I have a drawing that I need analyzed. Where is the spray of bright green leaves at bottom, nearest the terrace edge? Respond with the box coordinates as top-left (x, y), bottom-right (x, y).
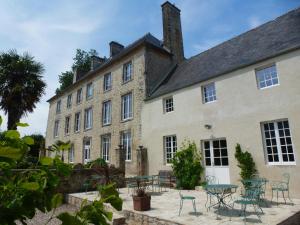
top-left (57, 184), bottom-right (123, 225)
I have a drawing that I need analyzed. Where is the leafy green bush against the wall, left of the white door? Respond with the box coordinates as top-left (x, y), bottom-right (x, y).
top-left (172, 141), bottom-right (203, 189)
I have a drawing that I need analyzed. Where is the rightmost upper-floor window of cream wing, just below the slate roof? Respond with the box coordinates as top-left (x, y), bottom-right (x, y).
top-left (255, 65), bottom-right (279, 89)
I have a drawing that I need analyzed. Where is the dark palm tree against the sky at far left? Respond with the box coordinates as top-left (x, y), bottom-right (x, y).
top-left (0, 50), bottom-right (46, 130)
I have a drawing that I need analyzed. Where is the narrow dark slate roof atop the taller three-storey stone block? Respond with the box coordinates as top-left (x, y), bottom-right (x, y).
top-left (47, 33), bottom-right (171, 102)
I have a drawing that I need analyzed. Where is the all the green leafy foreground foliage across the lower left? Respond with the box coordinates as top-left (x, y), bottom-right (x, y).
top-left (0, 117), bottom-right (122, 225)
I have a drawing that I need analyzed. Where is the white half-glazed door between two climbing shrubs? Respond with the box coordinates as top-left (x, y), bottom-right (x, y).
top-left (203, 139), bottom-right (230, 184)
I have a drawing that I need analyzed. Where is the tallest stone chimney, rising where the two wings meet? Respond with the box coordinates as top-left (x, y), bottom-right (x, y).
top-left (161, 1), bottom-right (184, 62)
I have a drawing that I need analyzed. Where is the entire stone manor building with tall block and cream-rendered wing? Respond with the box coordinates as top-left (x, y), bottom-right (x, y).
top-left (46, 2), bottom-right (300, 197)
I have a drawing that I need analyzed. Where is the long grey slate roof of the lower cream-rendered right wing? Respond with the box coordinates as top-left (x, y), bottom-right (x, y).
top-left (147, 8), bottom-right (300, 99)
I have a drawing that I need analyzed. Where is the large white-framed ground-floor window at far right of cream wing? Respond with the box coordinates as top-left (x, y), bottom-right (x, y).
top-left (262, 120), bottom-right (295, 165)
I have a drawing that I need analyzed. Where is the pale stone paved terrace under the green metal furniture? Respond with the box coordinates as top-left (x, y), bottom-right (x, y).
top-left (69, 188), bottom-right (300, 225)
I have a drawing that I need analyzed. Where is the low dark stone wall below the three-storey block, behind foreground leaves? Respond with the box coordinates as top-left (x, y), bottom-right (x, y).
top-left (57, 163), bottom-right (125, 193)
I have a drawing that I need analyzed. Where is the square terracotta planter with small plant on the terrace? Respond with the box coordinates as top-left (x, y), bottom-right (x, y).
top-left (132, 181), bottom-right (151, 211)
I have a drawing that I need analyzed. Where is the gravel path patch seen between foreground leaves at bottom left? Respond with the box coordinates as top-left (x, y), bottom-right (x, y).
top-left (17, 204), bottom-right (78, 225)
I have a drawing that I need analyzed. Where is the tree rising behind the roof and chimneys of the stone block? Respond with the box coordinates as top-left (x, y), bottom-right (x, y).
top-left (56, 49), bottom-right (98, 94)
